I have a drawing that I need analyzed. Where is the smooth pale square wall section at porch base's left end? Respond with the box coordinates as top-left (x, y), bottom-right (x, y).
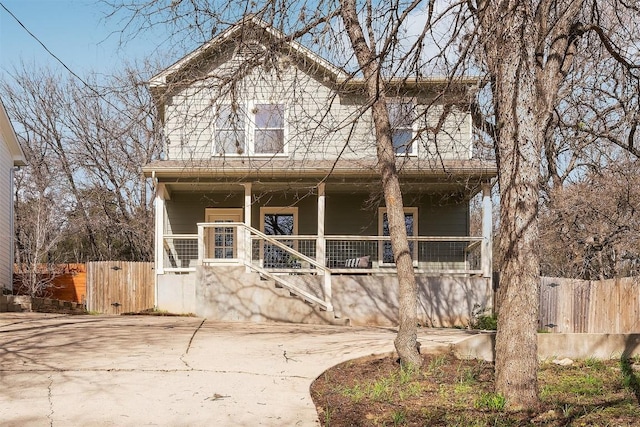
top-left (156, 274), bottom-right (196, 314)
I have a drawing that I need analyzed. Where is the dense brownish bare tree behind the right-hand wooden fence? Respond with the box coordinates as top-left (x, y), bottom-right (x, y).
top-left (541, 155), bottom-right (640, 280)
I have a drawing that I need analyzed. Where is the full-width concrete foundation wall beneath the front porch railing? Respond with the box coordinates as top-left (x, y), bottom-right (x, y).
top-left (158, 266), bottom-right (493, 327)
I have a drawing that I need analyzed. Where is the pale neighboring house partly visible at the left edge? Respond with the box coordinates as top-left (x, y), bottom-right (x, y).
top-left (0, 98), bottom-right (27, 289)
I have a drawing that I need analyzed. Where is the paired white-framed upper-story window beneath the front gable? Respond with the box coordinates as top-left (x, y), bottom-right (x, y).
top-left (213, 103), bottom-right (285, 155)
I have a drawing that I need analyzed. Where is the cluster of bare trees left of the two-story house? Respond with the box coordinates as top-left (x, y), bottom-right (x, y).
top-left (0, 64), bottom-right (159, 270)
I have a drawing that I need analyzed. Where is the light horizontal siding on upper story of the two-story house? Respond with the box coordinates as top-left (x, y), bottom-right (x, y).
top-left (165, 49), bottom-right (471, 164)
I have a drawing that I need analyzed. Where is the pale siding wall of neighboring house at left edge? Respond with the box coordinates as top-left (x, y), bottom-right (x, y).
top-left (0, 133), bottom-right (13, 288)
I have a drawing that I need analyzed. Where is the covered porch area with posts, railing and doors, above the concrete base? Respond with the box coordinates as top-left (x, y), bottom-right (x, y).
top-left (155, 177), bottom-right (492, 277)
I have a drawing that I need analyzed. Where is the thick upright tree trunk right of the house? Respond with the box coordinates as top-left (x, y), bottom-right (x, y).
top-left (482, 1), bottom-right (546, 409)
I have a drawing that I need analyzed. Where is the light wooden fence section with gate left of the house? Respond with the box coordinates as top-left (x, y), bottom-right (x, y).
top-left (87, 261), bottom-right (155, 314)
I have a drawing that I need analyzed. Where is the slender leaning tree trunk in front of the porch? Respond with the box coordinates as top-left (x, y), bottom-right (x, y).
top-left (340, 0), bottom-right (422, 366)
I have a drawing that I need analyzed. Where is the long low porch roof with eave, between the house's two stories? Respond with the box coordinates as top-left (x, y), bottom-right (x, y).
top-left (143, 158), bottom-right (496, 194)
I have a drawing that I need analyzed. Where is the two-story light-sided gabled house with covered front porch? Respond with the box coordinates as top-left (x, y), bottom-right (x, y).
top-left (144, 17), bottom-right (496, 325)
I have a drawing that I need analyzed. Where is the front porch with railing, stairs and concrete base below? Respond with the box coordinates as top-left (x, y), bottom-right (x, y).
top-left (150, 179), bottom-right (492, 326)
